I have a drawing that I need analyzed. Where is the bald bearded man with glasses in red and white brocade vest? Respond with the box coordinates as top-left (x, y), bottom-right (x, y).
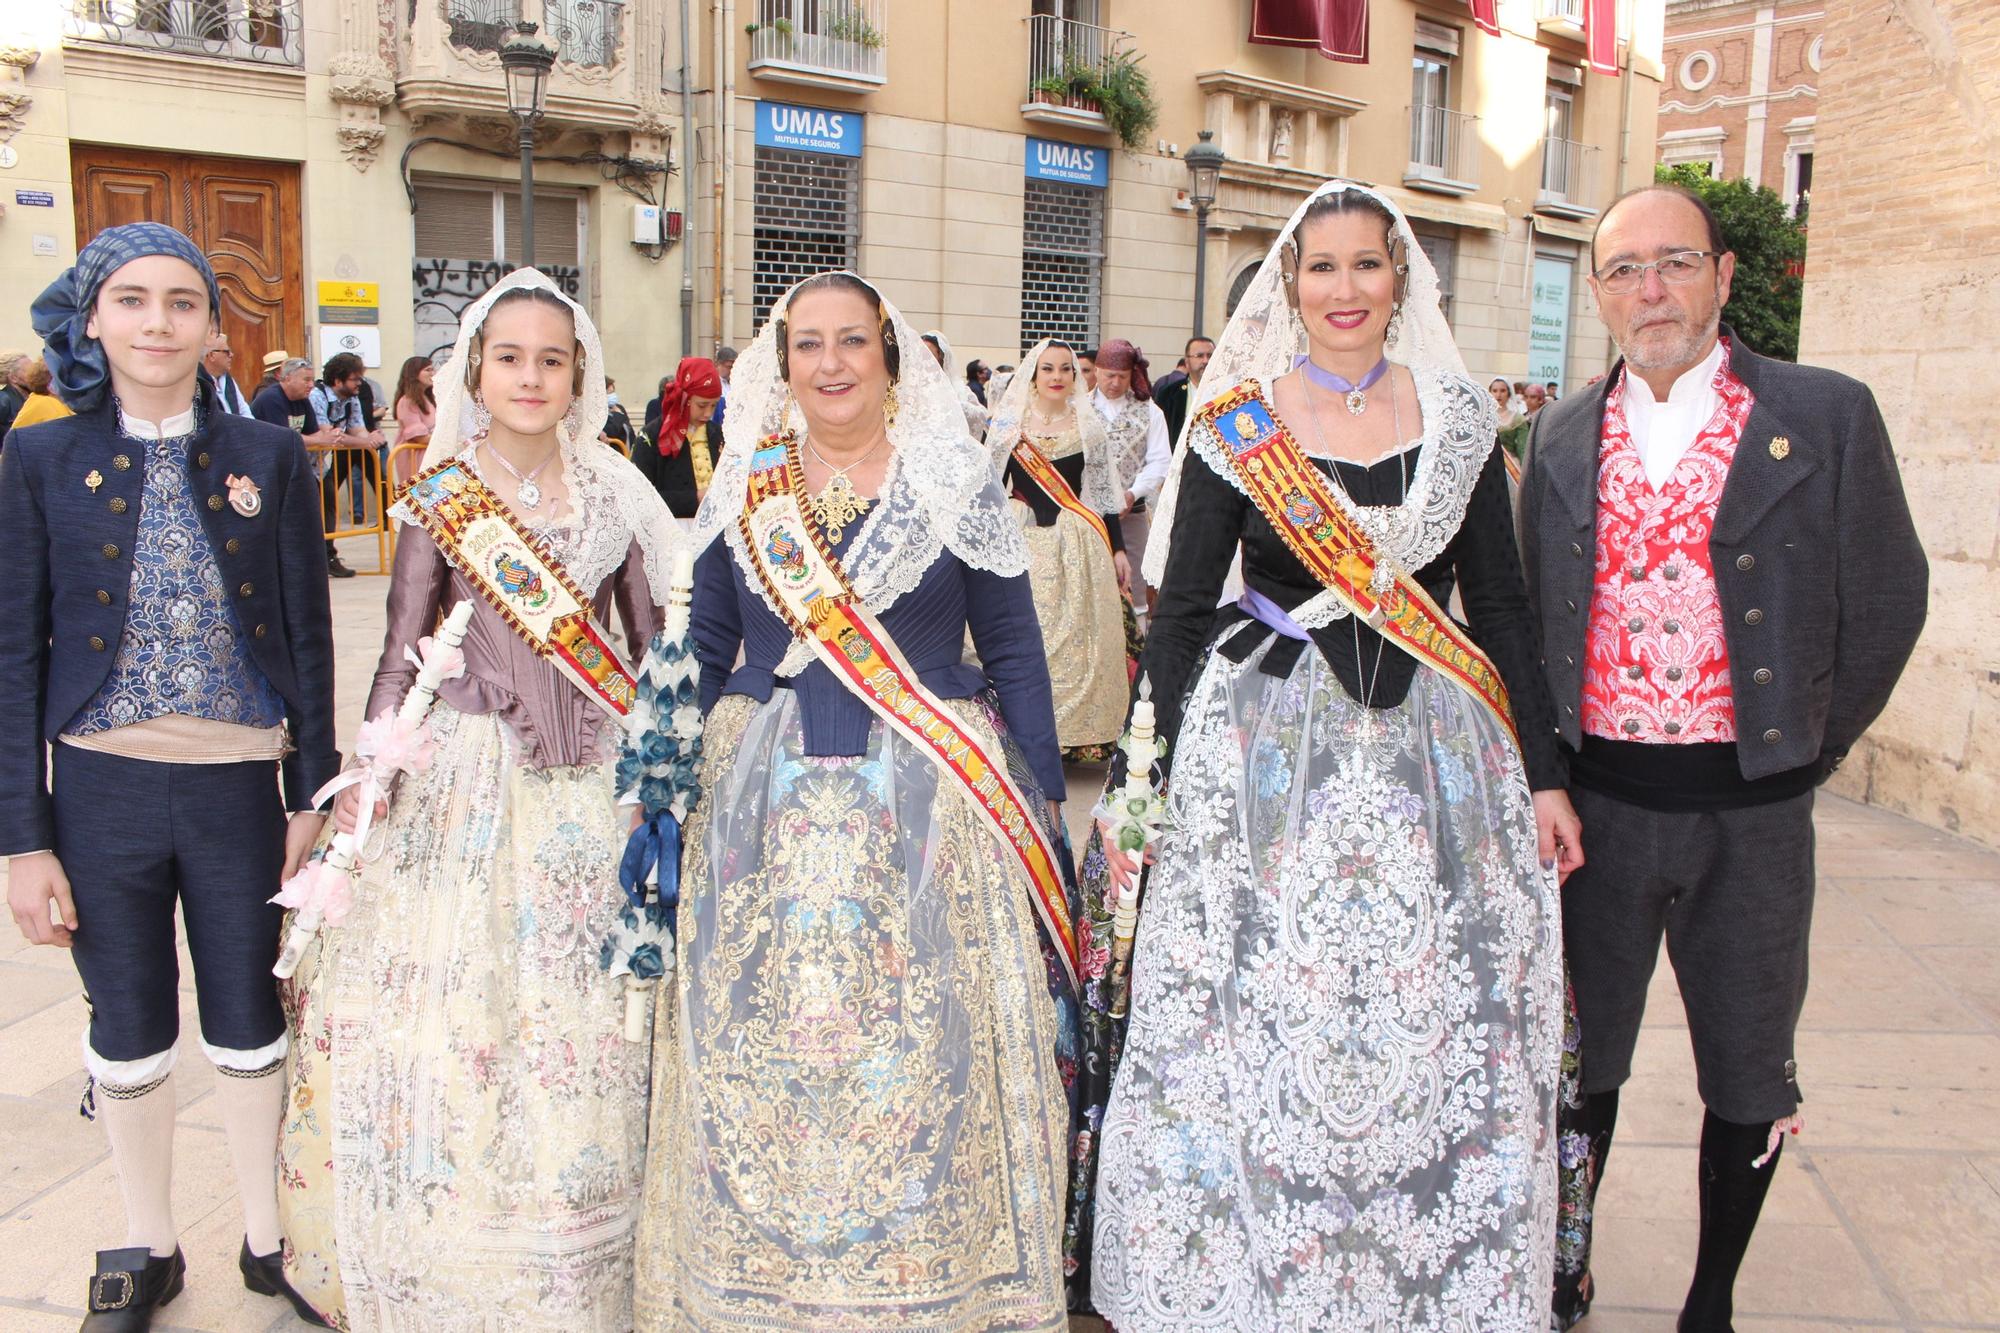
top-left (1522, 186), bottom-right (1928, 1333)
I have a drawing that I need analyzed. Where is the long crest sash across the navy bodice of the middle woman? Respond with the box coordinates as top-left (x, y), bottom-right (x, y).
top-left (738, 436), bottom-right (1076, 987)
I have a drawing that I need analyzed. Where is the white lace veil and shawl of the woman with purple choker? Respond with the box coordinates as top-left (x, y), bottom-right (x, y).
top-left (1144, 180), bottom-right (1500, 592)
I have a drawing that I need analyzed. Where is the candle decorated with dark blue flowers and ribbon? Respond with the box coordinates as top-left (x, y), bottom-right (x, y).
top-left (598, 552), bottom-right (702, 1041)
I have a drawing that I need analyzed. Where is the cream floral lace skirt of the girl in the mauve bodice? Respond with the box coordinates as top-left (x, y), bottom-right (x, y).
top-left (280, 703), bottom-right (650, 1333)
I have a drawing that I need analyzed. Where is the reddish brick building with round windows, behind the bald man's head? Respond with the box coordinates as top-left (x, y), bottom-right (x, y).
top-left (1660, 0), bottom-right (1838, 216)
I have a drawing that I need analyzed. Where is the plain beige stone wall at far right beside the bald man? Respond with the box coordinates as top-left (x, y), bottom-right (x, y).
top-left (1800, 0), bottom-right (2000, 845)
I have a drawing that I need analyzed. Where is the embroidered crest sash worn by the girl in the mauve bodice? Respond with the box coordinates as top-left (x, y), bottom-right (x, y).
top-left (404, 458), bottom-right (636, 719)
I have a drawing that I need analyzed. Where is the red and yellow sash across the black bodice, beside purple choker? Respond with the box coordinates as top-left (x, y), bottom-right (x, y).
top-left (1198, 382), bottom-right (1520, 747)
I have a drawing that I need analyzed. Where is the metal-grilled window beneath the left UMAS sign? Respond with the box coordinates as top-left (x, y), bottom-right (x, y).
top-left (750, 148), bottom-right (862, 328)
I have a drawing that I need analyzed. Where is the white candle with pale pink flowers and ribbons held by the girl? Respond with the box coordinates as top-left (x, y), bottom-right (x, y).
top-left (270, 600), bottom-right (472, 979)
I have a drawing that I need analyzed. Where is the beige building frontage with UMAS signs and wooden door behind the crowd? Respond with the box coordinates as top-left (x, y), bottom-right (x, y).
top-left (0, 0), bottom-right (1664, 404)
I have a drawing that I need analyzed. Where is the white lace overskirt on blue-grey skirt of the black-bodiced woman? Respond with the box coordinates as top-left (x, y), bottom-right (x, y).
top-left (1092, 646), bottom-right (1562, 1333)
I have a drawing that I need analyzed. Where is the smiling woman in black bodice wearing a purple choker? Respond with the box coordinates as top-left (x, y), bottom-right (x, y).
top-left (1084, 180), bottom-right (1582, 1333)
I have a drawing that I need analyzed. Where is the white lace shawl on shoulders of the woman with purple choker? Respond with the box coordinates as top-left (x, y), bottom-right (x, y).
top-left (1184, 370), bottom-right (1494, 628)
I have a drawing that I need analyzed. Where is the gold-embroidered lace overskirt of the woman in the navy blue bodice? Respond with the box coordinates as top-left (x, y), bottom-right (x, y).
top-left (638, 691), bottom-right (1068, 1333)
